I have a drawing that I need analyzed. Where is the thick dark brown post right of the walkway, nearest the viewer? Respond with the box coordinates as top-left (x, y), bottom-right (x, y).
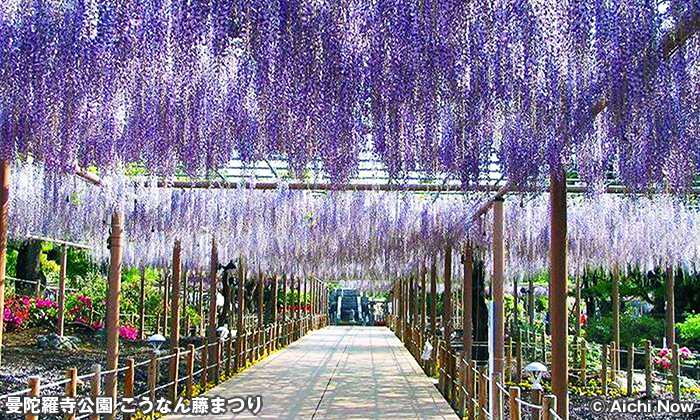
top-left (549, 166), bottom-right (569, 420)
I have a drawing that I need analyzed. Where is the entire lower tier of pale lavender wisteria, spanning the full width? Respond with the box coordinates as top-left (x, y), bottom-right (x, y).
top-left (9, 164), bottom-right (700, 288)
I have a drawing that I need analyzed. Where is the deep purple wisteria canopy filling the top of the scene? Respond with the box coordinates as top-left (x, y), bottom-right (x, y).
top-left (0, 0), bottom-right (700, 189)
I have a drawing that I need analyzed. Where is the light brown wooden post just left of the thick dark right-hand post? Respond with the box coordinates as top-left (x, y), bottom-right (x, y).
top-left (491, 198), bottom-right (505, 420)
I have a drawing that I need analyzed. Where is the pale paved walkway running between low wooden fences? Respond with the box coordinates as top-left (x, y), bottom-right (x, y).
top-left (167, 327), bottom-right (458, 420)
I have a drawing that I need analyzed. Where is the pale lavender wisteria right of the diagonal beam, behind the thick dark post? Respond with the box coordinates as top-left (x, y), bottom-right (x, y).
top-left (498, 194), bottom-right (700, 278)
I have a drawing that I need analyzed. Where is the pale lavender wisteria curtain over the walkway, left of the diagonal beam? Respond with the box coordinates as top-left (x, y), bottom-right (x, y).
top-left (9, 165), bottom-right (479, 287)
